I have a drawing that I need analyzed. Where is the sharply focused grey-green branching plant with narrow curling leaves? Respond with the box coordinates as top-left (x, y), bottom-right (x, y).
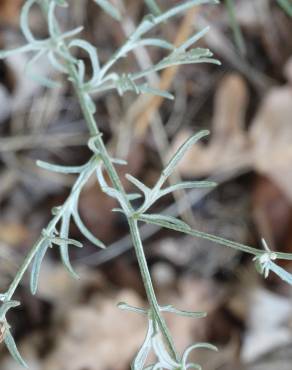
top-left (0, 0), bottom-right (292, 370)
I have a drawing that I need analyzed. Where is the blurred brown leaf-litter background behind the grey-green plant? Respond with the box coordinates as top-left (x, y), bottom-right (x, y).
top-left (0, 0), bottom-right (292, 370)
